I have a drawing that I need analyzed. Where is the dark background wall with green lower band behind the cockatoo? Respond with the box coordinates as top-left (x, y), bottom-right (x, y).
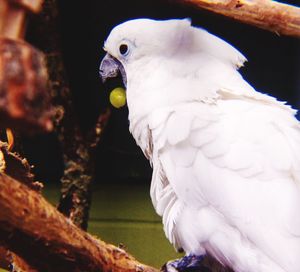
top-left (24, 0), bottom-right (300, 266)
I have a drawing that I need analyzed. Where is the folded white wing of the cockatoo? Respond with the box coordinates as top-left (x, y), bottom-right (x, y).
top-left (149, 95), bottom-right (300, 268)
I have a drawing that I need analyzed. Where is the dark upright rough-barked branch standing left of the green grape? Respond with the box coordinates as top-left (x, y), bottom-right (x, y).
top-left (47, 46), bottom-right (98, 230)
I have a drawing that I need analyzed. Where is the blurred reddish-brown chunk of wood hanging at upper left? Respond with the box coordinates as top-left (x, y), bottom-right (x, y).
top-left (0, 0), bottom-right (52, 132)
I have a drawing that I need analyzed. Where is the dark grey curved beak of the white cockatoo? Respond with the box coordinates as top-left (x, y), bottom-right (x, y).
top-left (99, 54), bottom-right (127, 87)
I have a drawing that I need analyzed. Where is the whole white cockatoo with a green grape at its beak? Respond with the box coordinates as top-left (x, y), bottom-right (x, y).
top-left (100, 19), bottom-right (300, 272)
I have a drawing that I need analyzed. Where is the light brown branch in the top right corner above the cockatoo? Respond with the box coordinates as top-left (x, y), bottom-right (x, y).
top-left (176, 0), bottom-right (300, 37)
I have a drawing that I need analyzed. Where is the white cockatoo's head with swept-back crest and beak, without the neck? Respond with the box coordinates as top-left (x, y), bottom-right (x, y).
top-left (99, 19), bottom-right (245, 85)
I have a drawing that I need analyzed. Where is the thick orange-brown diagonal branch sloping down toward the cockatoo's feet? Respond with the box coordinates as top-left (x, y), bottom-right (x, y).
top-left (0, 174), bottom-right (157, 272)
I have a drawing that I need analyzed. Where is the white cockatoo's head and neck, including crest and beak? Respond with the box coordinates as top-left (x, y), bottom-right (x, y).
top-left (99, 19), bottom-right (245, 118)
